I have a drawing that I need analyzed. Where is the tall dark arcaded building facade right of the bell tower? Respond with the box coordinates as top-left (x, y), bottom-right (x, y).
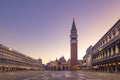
top-left (92, 20), bottom-right (120, 72)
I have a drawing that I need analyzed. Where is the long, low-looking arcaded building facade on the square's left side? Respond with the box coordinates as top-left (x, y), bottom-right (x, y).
top-left (0, 44), bottom-right (41, 72)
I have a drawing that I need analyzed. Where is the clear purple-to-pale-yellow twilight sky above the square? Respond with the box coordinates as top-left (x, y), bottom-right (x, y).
top-left (0, 0), bottom-right (120, 63)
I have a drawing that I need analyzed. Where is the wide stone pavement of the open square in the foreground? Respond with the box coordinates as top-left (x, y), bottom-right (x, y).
top-left (0, 71), bottom-right (120, 80)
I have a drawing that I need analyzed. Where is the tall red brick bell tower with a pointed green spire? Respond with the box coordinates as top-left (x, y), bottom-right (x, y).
top-left (70, 19), bottom-right (78, 70)
